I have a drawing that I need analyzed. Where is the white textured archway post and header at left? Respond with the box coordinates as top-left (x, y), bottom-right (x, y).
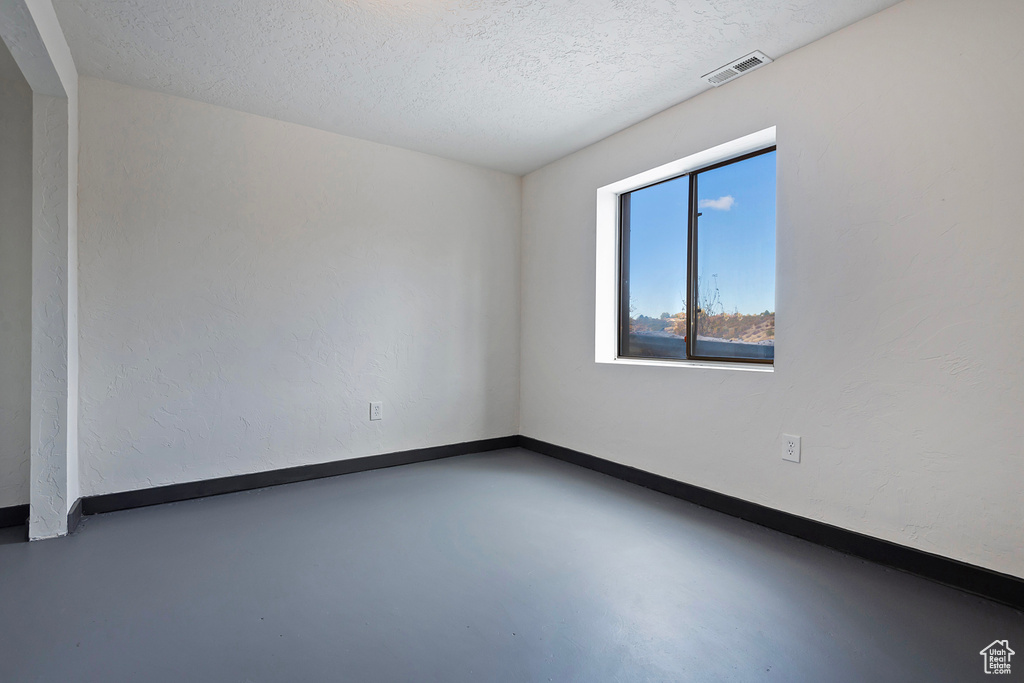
top-left (0, 0), bottom-right (78, 539)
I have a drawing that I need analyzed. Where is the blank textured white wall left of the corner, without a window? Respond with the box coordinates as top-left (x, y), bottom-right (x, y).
top-left (79, 79), bottom-right (520, 496)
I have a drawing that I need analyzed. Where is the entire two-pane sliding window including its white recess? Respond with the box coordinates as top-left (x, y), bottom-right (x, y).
top-left (597, 129), bottom-right (776, 370)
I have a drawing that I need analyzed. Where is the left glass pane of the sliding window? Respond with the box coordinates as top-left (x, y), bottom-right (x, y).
top-left (621, 176), bottom-right (689, 358)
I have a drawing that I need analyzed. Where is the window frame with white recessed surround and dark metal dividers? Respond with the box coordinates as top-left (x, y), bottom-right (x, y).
top-left (595, 127), bottom-right (777, 372)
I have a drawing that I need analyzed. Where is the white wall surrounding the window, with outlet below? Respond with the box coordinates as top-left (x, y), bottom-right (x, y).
top-left (521, 0), bottom-right (1024, 575)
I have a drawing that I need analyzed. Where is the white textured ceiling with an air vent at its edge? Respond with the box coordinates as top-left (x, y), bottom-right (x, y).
top-left (53, 0), bottom-right (896, 173)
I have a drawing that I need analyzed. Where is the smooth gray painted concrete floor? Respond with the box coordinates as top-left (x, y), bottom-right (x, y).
top-left (0, 450), bottom-right (1024, 683)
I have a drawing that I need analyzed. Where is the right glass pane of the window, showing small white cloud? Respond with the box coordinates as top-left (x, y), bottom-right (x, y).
top-left (693, 152), bottom-right (775, 359)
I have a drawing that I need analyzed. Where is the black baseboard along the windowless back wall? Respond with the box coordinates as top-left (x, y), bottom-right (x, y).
top-left (84, 436), bottom-right (519, 516)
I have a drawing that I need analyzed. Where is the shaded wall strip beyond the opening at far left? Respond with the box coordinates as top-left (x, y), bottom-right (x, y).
top-left (0, 41), bottom-right (32, 508)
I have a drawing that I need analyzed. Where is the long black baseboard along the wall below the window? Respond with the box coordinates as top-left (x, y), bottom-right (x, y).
top-left (519, 436), bottom-right (1024, 610)
